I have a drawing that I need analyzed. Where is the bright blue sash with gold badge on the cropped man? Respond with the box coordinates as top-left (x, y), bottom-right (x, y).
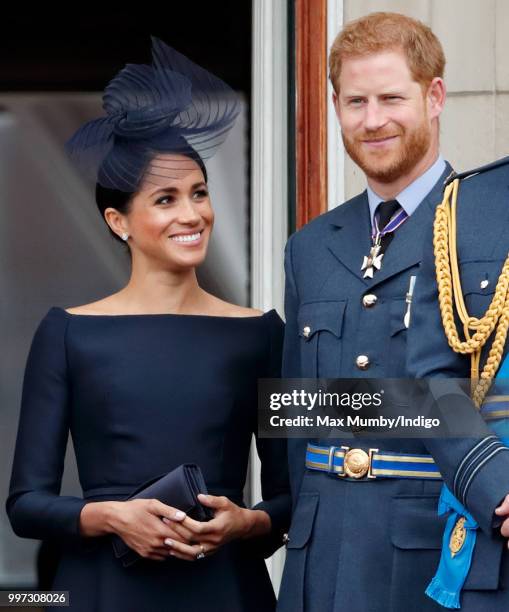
top-left (426, 356), bottom-right (509, 609)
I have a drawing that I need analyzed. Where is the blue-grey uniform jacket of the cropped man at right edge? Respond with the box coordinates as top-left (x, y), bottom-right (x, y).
top-left (408, 157), bottom-right (509, 612)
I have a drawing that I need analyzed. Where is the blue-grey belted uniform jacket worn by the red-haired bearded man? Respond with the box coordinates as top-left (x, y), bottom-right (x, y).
top-left (278, 166), bottom-right (451, 612)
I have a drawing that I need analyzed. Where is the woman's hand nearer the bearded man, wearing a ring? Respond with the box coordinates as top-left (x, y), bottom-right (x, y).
top-left (165, 494), bottom-right (271, 561)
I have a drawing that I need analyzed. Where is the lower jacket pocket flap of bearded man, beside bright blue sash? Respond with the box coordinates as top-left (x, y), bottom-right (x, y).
top-left (390, 495), bottom-right (445, 549)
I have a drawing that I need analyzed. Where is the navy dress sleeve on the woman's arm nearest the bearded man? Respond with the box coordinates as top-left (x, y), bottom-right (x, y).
top-left (253, 312), bottom-right (291, 557)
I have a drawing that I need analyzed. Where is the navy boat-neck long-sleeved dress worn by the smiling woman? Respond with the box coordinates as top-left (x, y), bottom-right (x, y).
top-left (7, 308), bottom-right (291, 612)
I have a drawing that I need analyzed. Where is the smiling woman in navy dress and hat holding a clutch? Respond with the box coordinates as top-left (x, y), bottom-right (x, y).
top-left (7, 39), bottom-right (290, 612)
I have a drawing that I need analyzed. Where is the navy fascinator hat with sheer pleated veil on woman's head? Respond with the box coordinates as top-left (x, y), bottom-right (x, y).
top-left (66, 37), bottom-right (240, 192)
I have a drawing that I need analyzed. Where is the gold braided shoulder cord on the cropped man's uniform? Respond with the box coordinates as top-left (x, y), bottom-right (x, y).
top-left (433, 179), bottom-right (509, 407)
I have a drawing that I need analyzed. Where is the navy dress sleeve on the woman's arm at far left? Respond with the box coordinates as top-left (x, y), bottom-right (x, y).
top-left (7, 309), bottom-right (85, 539)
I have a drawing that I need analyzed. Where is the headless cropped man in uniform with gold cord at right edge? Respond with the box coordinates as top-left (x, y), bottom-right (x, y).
top-left (407, 157), bottom-right (509, 612)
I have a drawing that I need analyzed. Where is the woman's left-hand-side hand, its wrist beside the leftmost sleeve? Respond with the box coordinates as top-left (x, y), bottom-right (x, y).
top-left (80, 499), bottom-right (194, 561)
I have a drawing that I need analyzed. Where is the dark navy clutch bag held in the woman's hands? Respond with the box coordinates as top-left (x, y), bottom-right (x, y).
top-left (112, 463), bottom-right (214, 567)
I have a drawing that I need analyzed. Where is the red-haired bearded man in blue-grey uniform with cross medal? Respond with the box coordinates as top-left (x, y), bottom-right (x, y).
top-left (279, 13), bottom-right (451, 612)
